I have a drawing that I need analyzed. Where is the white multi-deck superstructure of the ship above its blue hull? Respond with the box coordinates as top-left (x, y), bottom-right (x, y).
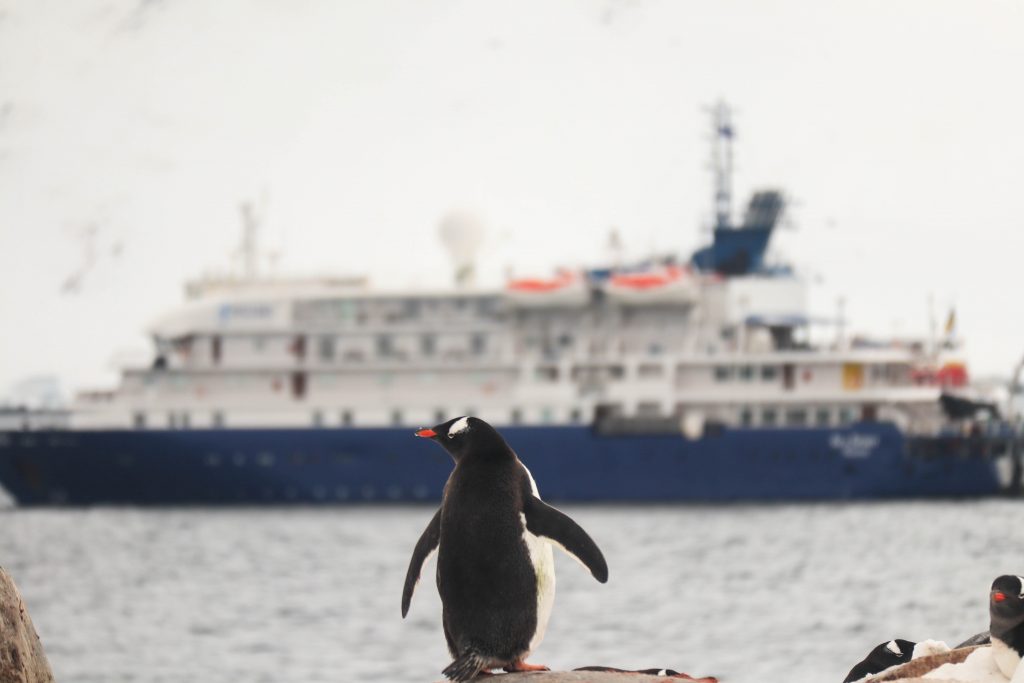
top-left (74, 268), bottom-right (966, 438)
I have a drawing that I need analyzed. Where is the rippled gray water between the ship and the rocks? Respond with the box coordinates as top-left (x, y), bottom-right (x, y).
top-left (0, 501), bottom-right (1024, 683)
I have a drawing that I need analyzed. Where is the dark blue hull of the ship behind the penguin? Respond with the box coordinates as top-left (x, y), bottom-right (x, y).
top-left (0, 424), bottom-right (1007, 505)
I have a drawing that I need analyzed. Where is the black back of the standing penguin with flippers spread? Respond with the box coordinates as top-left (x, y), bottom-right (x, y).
top-left (437, 441), bottom-right (537, 661)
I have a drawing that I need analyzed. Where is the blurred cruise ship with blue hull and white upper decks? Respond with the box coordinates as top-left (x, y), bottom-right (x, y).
top-left (0, 105), bottom-right (1021, 506)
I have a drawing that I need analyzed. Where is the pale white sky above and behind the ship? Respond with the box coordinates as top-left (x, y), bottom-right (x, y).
top-left (0, 0), bottom-right (1024, 395)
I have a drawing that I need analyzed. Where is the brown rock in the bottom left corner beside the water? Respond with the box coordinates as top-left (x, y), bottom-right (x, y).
top-left (0, 567), bottom-right (53, 683)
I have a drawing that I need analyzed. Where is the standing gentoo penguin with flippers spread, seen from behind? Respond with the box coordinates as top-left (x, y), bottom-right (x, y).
top-left (401, 416), bottom-right (608, 681)
